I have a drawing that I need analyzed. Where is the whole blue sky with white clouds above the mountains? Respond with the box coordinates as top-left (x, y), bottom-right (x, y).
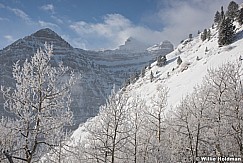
top-left (0, 0), bottom-right (242, 50)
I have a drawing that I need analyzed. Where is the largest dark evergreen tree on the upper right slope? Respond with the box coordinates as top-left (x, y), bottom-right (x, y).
top-left (218, 17), bottom-right (235, 46)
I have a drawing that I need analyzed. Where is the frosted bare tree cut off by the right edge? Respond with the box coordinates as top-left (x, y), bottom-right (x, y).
top-left (222, 62), bottom-right (243, 159)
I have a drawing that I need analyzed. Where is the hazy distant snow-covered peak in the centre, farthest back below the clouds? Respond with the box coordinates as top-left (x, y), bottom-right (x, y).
top-left (86, 37), bottom-right (174, 86)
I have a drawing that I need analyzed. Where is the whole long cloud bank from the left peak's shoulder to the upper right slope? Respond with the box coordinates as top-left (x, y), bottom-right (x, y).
top-left (70, 0), bottom-right (240, 49)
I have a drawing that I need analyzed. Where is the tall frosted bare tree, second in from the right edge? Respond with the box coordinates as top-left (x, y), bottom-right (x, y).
top-left (205, 64), bottom-right (237, 156)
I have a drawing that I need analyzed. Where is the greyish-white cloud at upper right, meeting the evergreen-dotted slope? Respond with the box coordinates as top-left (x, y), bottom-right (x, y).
top-left (155, 0), bottom-right (242, 44)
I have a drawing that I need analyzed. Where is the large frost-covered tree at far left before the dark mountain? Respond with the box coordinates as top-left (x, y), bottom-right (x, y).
top-left (0, 44), bottom-right (76, 163)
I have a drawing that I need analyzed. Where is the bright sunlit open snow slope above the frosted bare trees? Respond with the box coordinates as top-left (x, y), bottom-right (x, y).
top-left (63, 20), bottom-right (243, 162)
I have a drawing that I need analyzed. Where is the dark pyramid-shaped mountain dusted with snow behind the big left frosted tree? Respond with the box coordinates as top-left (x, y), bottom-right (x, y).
top-left (0, 29), bottom-right (114, 125)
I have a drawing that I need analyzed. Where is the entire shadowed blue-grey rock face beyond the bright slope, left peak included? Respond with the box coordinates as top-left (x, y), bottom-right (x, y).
top-left (0, 28), bottom-right (175, 128)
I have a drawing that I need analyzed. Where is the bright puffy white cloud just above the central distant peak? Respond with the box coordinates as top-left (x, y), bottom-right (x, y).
top-left (70, 14), bottom-right (165, 49)
